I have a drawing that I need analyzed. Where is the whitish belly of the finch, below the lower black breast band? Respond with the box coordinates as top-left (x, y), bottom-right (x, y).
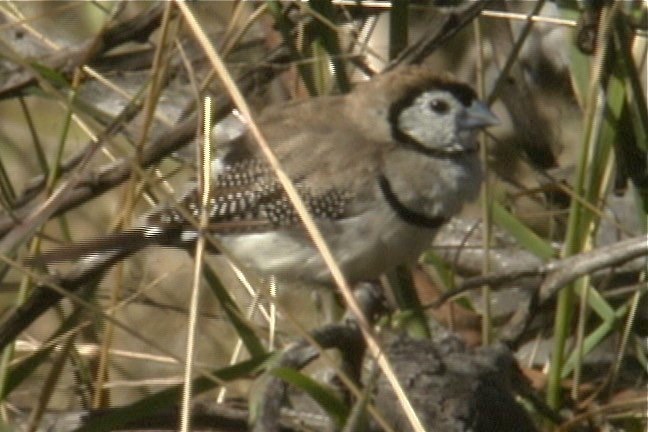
top-left (221, 202), bottom-right (435, 283)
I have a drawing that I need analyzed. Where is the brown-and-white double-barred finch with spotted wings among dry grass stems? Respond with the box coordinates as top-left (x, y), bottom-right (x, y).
top-left (29, 66), bottom-right (497, 282)
